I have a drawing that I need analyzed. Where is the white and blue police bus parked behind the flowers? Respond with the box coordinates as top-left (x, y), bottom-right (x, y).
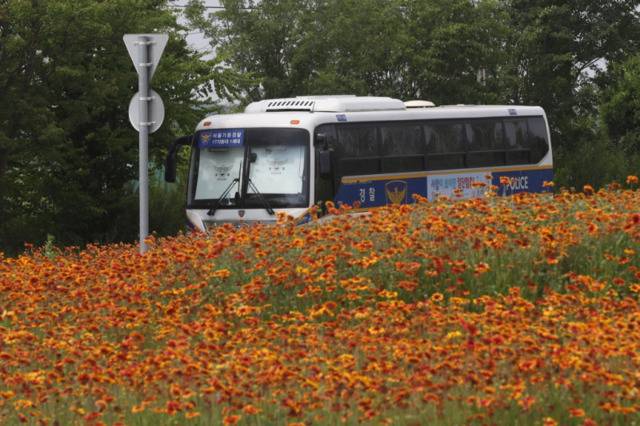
top-left (165, 96), bottom-right (553, 231)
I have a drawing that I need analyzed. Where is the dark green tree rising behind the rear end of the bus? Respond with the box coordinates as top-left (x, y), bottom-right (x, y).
top-left (504, 0), bottom-right (640, 140)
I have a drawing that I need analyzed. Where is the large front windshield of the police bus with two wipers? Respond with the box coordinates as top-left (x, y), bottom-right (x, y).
top-left (189, 128), bottom-right (309, 209)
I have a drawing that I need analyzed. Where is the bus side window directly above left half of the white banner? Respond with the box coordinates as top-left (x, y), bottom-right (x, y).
top-left (424, 121), bottom-right (466, 170)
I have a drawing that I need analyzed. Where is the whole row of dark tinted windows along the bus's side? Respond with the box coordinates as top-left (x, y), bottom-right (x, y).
top-left (324, 113), bottom-right (549, 176)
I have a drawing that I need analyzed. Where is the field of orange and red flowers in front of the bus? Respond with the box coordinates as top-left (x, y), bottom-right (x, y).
top-left (0, 184), bottom-right (640, 425)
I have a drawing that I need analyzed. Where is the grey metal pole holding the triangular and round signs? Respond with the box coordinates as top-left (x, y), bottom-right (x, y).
top-left (138, 37), bottom-right (151, 254)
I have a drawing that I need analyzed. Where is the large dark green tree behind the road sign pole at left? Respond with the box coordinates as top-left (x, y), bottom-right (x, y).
top-left (0, 0), bottom-right (238, 250)
